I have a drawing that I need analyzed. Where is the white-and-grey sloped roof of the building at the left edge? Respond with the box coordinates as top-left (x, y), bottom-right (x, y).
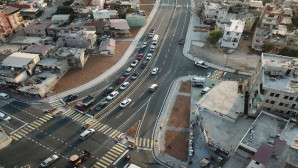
top-left (2, 52), bottom-right (39, 68)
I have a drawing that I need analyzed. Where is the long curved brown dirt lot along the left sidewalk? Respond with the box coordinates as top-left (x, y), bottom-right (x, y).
top-left (53, 41), bottom-right (131, 94)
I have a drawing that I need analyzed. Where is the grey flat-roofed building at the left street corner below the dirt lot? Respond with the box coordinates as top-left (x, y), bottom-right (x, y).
top-left (17, 58), bottom-right (69, 97)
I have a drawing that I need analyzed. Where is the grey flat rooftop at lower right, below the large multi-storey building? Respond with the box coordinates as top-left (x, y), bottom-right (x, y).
top-left (241, 112), bottom-right (287, 150)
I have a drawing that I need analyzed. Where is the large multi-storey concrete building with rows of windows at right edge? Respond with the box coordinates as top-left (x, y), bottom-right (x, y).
top-left (247, 53), bottom-right (298, 118)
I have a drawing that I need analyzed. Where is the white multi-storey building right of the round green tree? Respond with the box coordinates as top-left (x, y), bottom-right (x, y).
top-left (220, 20), bottom-right (245, 49)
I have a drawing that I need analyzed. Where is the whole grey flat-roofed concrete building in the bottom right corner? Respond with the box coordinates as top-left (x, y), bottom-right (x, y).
top-left (235, 111), bottom-right (298, 168)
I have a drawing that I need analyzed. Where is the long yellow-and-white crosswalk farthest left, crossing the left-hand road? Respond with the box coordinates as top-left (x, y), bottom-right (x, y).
top-left (10, 114), bottom-right (53, 141)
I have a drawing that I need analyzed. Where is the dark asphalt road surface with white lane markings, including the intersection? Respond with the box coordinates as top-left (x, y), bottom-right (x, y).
top-left (0, 0), bottom-right (250, 167)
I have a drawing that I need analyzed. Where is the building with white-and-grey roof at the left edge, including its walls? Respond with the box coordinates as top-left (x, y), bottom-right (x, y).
top-left (0, 52), bottom-right (40, 86)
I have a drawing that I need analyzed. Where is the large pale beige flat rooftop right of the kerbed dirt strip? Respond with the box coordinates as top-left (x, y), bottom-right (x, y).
top-left (197, 81), bottom-right (244, 120)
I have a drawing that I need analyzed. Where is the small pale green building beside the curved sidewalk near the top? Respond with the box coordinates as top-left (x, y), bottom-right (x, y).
top-left (126, 12), bottom-right (147, 27)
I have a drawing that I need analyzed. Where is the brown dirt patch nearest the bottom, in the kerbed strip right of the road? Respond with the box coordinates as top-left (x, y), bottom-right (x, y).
top-left (165, 131), bottom-right (188, 160)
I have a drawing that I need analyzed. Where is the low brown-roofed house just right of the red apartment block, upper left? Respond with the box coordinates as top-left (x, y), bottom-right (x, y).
top-left (24, 19), bottom-right (52, 36)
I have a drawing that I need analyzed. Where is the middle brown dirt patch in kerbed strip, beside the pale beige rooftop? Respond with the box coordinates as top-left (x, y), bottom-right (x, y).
top-left (168, 95), bottom-right (190, 128)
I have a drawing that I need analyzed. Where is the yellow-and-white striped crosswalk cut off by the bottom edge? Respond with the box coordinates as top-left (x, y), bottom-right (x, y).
top-left (92, 143), bottom-right (128, 168)
